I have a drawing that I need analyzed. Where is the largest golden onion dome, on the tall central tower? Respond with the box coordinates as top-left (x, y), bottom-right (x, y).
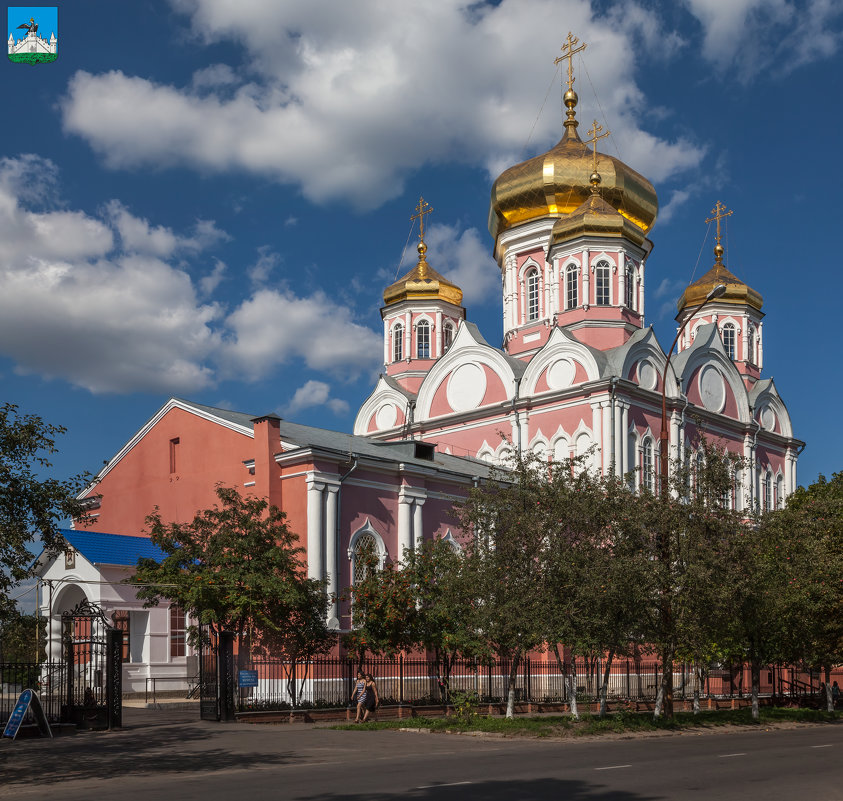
top-left (489, 90), bottom-right (659, 241)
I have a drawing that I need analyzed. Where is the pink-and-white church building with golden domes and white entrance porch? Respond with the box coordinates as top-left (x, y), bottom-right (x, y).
top-left (36, 40), bottom-right (804, 682)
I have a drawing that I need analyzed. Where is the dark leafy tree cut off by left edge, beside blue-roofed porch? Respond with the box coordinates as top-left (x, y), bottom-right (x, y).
top-left (0, 403), bottom-right (89, 617)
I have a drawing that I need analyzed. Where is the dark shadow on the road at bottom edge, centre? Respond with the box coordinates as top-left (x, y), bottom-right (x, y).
top-left (299, 779), bottom-right (667, 801)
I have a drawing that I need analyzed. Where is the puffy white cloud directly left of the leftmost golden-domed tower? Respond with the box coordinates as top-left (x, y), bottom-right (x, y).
top-left (223, 289), bottom-right (383, 379)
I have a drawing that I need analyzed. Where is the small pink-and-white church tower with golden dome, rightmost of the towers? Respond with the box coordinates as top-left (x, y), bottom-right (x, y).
top-left (676, 200), bottom-right (764, 389)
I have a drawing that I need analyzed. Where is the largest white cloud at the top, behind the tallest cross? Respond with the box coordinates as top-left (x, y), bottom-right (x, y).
top-left (61, 0), bottom-right (703, 209)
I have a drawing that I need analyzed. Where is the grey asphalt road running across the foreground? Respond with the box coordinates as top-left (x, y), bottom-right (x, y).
top-left (0, 712), bottom-right (843, 801)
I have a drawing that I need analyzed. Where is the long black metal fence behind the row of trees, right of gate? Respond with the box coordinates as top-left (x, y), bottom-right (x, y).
top-left (235, 657), bottom-right (843, 711)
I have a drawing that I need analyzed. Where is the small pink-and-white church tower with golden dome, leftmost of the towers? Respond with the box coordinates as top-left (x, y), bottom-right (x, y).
top-left (381, 198), bottom-right (465, 392)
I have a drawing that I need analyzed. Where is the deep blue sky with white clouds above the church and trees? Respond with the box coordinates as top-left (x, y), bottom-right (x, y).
top-left (0, 0), bottom-right (843, 504)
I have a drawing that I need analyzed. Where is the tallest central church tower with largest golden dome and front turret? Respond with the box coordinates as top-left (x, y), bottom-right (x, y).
top-left (489, 34), bottom-right (658, 358)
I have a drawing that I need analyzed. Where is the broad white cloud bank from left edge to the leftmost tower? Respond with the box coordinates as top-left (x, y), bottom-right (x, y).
top-left (0, 155), bottom-right (381, 394)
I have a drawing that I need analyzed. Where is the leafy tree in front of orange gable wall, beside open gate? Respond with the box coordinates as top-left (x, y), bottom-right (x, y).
top-left (131, 486), bottom-right (328, 658)
